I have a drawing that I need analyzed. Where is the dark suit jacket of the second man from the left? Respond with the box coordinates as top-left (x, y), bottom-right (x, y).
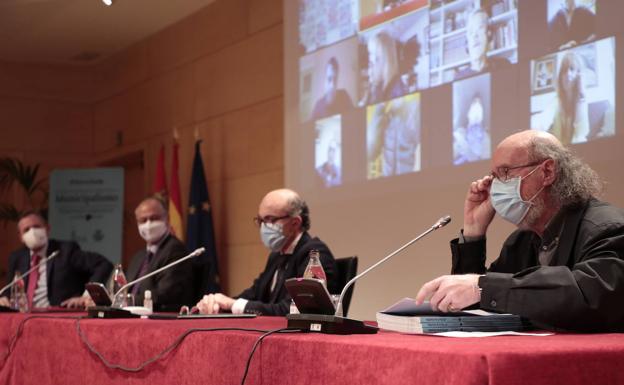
top-left (127, 235), bottom-right (196, 312)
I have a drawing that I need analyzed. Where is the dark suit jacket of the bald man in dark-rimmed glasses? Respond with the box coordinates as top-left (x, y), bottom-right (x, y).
top-left (238, 232), bottom-right (339, 315)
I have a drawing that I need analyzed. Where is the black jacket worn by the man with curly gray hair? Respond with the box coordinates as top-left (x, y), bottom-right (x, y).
top-left (451, 199), bottom-right (624, 332)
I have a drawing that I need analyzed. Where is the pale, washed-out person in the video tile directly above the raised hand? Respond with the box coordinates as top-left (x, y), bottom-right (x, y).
top-left (453, 94), bottom-right (490, 165)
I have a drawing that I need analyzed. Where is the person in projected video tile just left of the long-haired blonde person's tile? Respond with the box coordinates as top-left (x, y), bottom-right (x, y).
top-left (311, 57), bottom-right (353, 120)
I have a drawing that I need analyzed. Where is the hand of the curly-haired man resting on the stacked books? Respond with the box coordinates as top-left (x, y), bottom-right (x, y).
top-left (416, 274), bottom-right (481, 313)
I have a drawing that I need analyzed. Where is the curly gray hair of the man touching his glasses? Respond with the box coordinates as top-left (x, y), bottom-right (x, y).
top-left (528, 136), bottom-right (603, 207)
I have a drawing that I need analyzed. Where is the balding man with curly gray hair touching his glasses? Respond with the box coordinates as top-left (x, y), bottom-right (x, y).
top-left (416, 131), bottom-right (624, 332)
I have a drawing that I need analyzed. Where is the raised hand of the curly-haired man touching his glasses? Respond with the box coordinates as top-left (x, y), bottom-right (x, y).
top-left (464, 175), bottom-right (496, 237)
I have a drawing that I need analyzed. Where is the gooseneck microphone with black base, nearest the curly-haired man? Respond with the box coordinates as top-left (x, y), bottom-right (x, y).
top-left (286, 215), bottom-right (451, 334)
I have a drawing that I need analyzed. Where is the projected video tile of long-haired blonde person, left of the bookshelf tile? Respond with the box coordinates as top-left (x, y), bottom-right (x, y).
top-left (358, 8), bottom-right (429, 107)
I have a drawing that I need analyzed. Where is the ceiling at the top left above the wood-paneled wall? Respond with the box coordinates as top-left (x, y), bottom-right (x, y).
top-left (0, 0), bottom-right (215, 64)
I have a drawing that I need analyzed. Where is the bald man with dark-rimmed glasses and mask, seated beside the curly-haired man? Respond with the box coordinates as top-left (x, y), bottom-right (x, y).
top-left (197, 189), bottom-right (338, 315)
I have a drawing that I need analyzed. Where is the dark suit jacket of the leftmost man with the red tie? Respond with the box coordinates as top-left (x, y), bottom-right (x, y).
top-left (8, 239), bottom-right (113, 306)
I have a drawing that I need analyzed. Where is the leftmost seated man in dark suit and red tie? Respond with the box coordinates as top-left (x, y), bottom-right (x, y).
top-left (0, 211), bottom-right (113, 308)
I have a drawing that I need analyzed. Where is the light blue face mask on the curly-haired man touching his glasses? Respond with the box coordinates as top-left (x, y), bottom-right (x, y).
top-left (490, 166), bottom-right (544, 225)
